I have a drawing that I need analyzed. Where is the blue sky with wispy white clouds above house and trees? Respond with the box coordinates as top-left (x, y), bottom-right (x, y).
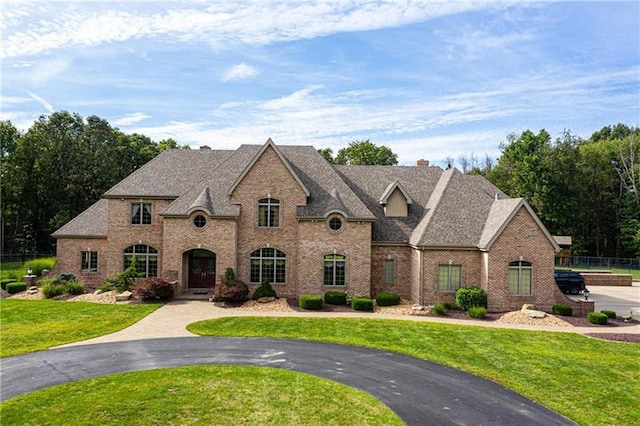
top-left (0, 0), bottom-right (640, 164)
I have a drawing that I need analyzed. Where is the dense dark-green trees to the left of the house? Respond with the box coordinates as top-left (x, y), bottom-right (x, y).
top-left (0, 111), bottom-right (188, 254)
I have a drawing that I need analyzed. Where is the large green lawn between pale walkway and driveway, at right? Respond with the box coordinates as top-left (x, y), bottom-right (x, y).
top-left (188, 317), bottom-right (640, 425)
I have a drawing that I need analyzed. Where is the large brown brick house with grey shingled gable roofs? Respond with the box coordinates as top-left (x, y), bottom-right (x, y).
top-left (53, 139), bottom-right (571, 311)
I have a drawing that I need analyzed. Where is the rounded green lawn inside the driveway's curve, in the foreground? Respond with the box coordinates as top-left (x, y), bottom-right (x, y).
top-left (0, 366), bottom-right (403, 426)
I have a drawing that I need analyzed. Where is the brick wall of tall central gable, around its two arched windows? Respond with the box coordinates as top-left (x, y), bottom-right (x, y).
top-left (231, 147), bottom-right (306, 296)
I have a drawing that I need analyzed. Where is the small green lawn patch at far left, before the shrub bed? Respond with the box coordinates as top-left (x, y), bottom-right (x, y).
top-left (0, 299), bottom-right (162, 357)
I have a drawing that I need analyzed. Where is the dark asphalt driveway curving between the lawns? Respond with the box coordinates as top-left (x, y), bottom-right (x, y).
top-left (0, 337), bottom-right (574, 425)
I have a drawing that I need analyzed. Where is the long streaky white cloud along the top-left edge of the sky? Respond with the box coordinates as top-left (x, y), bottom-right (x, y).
top-left (0, 0), bottom-right (495, 58)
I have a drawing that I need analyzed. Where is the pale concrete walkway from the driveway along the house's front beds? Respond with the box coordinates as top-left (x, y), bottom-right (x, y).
top-left (57, 300), bottom-right (640, 347)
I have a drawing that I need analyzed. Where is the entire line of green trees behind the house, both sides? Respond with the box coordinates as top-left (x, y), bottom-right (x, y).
top-left (0, 111), bottom-right (640, 257)
